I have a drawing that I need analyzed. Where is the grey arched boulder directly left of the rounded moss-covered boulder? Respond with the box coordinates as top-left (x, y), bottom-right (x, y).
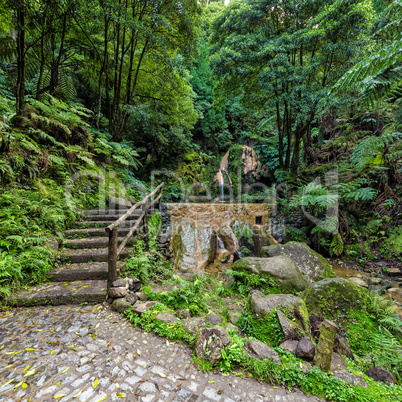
top-left (250, 290), bottom-right (309, 329)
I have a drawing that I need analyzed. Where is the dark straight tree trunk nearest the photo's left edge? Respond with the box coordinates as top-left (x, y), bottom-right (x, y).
top-left (15, 0), bottom-right (25, 114)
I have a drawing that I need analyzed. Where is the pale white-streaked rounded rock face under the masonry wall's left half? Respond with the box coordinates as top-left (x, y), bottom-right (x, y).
top-left (172, 221), bottom-right (217, 273)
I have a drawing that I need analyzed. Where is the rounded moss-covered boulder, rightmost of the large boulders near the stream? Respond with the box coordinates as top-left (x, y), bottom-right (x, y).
top-left (302, 278), bottom-right (369, 319)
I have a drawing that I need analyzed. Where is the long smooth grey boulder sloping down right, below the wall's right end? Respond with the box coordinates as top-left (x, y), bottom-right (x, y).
top-left (232, 256), bottom-right (309, 292)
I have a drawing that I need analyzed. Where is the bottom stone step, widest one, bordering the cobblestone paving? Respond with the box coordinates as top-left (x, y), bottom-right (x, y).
top-left (9, 280), bottom-right (107, 306)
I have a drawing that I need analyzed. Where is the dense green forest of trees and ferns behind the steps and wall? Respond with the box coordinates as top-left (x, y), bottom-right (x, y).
top-left (0, 0), bottom-right (402, 294)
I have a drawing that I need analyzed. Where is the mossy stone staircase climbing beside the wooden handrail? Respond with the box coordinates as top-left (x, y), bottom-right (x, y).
top-left (9, 209), bottom-right (148, 306)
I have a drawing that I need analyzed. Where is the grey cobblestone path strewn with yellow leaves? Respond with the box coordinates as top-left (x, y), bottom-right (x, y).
top-left (0, 304), bottom-right (319, 402)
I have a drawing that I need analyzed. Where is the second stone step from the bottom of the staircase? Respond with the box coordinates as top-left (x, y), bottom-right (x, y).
top-left (48, 261), bottom-right (126, 282)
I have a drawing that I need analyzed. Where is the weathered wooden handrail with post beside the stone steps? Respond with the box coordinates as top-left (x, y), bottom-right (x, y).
top-left (105, 183), bottom-right (165, 290)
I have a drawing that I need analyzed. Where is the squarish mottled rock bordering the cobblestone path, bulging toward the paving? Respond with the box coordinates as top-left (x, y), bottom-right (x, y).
top-left (195, 328), bottom-right (231, 365)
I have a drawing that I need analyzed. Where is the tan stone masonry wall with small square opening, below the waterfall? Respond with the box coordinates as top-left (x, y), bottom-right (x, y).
top-left (165, 203), bottom-right (272, 235)
